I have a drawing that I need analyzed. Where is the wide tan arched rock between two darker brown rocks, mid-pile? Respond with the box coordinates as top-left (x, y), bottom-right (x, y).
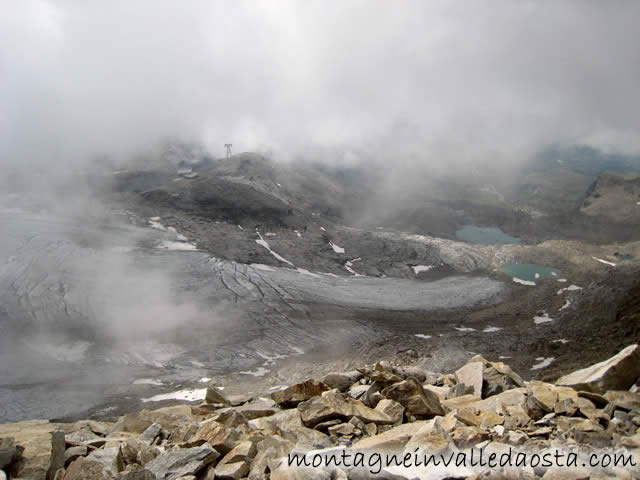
top-left (298, 390), bottom-right (393, 428)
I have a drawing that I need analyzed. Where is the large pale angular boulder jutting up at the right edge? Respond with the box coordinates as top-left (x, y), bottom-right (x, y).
top-left (556, 344), bottom-right (640, 393)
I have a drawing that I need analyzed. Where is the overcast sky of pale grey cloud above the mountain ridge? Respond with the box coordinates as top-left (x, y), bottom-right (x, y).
top-left (0, 0), bottom-right (640, 173)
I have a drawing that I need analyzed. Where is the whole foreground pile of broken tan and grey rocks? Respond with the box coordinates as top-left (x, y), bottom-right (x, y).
top-left (0, 345), bottom-right (640, 480)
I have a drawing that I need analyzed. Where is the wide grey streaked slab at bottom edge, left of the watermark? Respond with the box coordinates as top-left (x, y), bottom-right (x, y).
top-left (145, 443), bottom-right (220, 480)
